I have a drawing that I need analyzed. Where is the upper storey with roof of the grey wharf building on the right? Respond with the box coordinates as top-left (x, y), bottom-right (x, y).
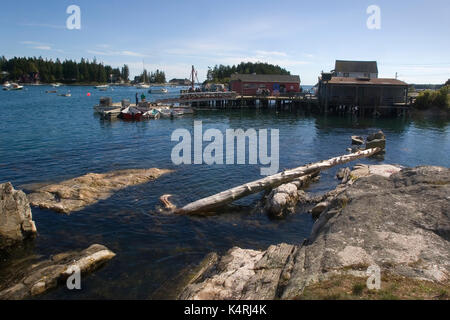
top-left (332, 60), bottom-right (378, 79)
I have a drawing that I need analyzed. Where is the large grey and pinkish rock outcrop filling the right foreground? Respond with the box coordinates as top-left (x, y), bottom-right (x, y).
top-left (179, 166), bottom-right (450, 299)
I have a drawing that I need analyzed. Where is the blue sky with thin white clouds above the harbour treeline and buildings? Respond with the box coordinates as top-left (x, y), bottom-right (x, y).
top-left (0, 0), bottom-right (450, 85)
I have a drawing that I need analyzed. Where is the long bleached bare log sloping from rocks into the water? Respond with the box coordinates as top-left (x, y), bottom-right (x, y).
top-left (175, 148), bottom-right (381, 214)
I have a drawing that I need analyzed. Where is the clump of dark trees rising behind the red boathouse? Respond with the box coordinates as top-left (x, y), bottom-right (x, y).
top-left (206, 62), bottom-right (291, 82)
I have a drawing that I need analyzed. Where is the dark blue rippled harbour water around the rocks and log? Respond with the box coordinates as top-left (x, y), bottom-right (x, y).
top-left (0, 87), bottom-right (450, 299)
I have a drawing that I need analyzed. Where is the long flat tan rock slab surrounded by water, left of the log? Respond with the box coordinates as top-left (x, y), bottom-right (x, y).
top-left (28, 168), bottom-right (171, 213)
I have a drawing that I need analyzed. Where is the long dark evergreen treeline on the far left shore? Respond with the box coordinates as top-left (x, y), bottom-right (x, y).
top-left (0, 56), bottom-right (130, 83)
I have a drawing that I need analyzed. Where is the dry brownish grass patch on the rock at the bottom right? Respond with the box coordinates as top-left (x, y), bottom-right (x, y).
top-left (296, 273), bottom-right (450, 300)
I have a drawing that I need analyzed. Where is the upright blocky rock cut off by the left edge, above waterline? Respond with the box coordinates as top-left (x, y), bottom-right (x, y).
top-left (0, 182), bottom-right (36, 249)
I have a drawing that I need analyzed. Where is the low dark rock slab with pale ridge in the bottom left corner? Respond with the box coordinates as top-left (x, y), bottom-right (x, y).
top-left (0, 244), bottom-right (115, 300)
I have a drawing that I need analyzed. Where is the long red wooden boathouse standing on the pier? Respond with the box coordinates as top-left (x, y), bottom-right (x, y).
top-left (230, 74), bottom-right (300, 96)
